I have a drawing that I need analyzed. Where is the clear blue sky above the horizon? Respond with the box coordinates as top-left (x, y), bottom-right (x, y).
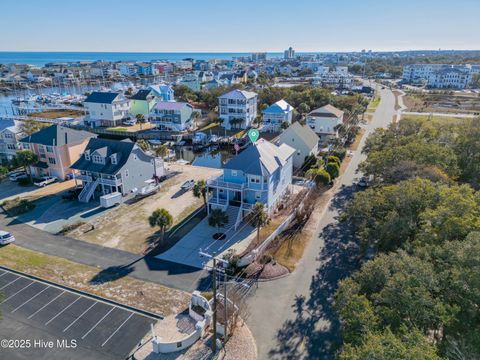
top-left (0, 0), bottom-right (480, 52)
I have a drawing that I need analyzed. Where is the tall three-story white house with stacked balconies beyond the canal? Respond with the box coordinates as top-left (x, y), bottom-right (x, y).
top-left (218, 90), bottom-right (258, 130)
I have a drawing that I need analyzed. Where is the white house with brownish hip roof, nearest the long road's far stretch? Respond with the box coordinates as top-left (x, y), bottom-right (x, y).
top-left (307, 104), bottom-right (343, 142)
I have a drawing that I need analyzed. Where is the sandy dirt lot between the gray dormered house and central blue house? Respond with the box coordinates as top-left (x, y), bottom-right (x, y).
top-left (68, 164), bottom-right (222, 253)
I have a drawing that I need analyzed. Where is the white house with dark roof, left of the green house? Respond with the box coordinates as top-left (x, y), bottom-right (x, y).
top-left (83, 91), bottom-right (132, 127)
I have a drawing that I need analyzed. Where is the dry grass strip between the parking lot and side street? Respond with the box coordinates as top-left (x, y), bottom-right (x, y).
top-left (0, 244), bottom-right (190, 316)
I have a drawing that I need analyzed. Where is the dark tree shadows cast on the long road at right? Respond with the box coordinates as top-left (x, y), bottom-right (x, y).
top-left (269, 187), bottom-right (359, 359)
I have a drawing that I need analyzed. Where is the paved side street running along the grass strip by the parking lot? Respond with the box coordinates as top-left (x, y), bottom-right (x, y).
top-left (0, 213), bottom-right (209, 292)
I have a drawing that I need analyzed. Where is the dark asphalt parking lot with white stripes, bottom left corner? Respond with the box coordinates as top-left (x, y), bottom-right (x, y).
top-left (0, 269), bottom-right (157, 359)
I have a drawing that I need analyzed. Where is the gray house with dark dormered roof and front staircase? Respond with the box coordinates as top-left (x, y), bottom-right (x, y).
top-left (71, 139), bottom-right (165, 202)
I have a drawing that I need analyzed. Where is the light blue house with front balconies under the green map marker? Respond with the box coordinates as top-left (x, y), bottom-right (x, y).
top-left (207, 139), bottom-right (295, 226)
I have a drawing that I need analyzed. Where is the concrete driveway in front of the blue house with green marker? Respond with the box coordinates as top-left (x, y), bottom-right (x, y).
top-left (156, 218), bottom-right (255, 269)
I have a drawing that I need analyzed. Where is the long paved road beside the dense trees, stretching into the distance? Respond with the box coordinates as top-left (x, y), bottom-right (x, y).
top-left (247, 85), bottom-right (397, 360)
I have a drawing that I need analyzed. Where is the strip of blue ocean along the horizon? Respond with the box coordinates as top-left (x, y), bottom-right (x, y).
top-left (0, 51), bottom-right (283, 66)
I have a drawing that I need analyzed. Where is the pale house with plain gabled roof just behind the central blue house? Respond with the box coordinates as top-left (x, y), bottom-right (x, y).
top-left (278, 122), bottom-right (320, 169)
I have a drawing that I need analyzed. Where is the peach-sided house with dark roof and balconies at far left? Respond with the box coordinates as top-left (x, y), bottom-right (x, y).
top-left (20, 125), bottom-right (97, 180)
